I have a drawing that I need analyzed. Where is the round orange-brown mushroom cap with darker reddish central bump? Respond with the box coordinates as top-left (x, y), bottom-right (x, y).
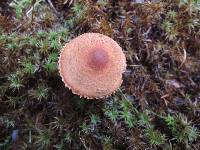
top-left (59, 33), bottom-right (126, 99)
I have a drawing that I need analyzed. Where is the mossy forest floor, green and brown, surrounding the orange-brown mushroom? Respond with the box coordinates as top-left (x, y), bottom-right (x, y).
top-left (0, 0), bottom-right (200, 150)
